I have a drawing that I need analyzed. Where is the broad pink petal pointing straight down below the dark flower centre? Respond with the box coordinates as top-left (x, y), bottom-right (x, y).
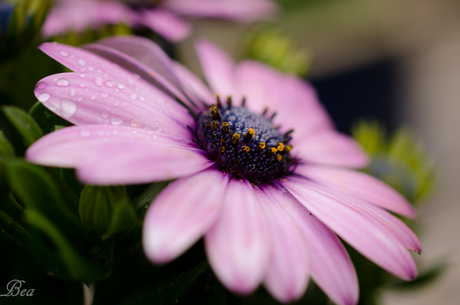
top-left (205, 180), bottom-right (271, 294)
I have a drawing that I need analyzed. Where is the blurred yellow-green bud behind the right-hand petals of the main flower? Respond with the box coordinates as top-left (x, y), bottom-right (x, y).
top-left (352, 121), bottom-right (437, 203)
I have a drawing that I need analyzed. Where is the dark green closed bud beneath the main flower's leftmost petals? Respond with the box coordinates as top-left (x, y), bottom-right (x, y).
top-left (79, 185), bottom-right (136, 239)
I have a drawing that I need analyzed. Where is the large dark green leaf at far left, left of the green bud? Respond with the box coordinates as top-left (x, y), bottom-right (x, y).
top-left (7, 160), bottom-right (82, 235)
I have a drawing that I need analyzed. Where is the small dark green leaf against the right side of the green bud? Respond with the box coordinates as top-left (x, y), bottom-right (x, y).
top-left (102, 200), bottom-right (137, 239)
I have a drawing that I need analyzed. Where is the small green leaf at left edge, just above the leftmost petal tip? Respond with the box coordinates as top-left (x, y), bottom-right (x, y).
top-left (2, 106), bottom-right (43, 146)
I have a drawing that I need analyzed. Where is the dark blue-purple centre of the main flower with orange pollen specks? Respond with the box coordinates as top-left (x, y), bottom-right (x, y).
top-left (195, 96), bottom-right (297, 183)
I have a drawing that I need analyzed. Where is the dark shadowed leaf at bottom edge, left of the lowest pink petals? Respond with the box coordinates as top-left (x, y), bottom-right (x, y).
top-left (121, 262), bottom-right (209, 305)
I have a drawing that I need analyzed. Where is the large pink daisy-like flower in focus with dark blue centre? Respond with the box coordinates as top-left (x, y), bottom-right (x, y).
top-left (26, 37), bottom-right (421, 304)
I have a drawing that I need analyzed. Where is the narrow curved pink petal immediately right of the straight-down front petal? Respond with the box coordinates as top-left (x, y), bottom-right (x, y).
top-left (256, 190), bottom-right (310, 303)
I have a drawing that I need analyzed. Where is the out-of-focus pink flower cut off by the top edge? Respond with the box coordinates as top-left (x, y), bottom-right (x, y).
top-left (42, 0), bottom-right (278, 42)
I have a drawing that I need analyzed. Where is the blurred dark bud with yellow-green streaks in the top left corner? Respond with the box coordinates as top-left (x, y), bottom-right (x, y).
top-left (0, 0), bottom-right (51, 59)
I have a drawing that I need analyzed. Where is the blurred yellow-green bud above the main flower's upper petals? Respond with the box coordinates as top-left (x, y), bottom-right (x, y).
top-left (246, 27), bottom-right (312, 77)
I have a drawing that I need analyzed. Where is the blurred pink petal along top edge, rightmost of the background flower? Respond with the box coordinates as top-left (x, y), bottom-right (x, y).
top-left (162, 0), bottom-right (278, 22)
